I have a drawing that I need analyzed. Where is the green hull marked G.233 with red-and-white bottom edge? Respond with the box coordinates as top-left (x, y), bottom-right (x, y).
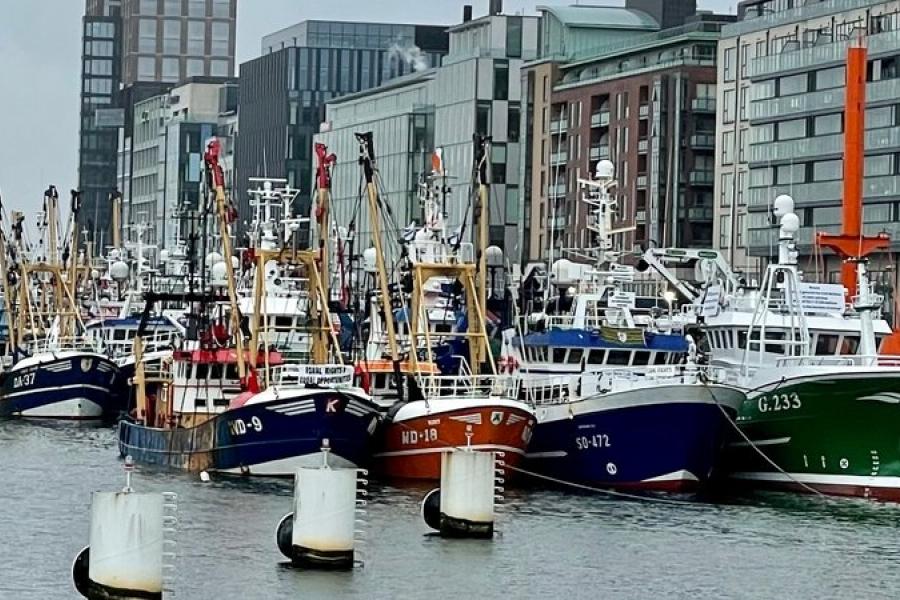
top-left (727, 368), bottom-right (900, 500)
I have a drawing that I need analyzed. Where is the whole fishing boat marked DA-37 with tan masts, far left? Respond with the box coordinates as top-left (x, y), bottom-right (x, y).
top-left (0, 186), bottom-right (125, 420)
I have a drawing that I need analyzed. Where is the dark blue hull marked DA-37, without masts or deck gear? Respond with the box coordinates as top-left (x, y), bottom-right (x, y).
top-left (0, 353), bottom-right (126, 420)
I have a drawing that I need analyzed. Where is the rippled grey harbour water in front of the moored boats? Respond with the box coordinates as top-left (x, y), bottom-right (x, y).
top-left (0, 422), bottom-right (900, 600)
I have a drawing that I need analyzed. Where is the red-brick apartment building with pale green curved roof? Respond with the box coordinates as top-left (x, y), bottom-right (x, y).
top-left (522, 1), bottom-right (728, 261)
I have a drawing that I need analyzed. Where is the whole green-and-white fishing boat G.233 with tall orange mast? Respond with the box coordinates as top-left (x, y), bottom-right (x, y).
top-left (684, 45), bottom-right (900, 500)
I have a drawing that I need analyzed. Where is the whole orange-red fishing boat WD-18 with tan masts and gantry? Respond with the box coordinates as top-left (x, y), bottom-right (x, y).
top-left (357, 133), bottom-right (534, 480)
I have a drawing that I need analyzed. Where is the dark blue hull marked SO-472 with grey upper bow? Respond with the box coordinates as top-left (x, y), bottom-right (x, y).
top-left (526, 384), bottom-right (744, 491)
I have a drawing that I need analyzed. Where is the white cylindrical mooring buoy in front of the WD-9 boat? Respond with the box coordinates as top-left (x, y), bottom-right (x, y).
top-left (275, 440), bottom-right (368, 569)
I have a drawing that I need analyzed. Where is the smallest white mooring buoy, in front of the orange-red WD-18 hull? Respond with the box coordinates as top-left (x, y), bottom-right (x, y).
top-left (422, 449), bottom-right (503, 538)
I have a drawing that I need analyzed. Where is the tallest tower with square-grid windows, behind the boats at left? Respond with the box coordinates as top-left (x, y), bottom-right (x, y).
top-left (79, 0), bottom-right (237, 242)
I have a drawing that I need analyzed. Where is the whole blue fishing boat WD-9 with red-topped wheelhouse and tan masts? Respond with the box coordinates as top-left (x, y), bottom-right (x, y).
top-left (119, 142), bottom-right (379, 475)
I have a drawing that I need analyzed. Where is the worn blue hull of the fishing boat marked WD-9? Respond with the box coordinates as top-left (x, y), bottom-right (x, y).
top-left (118, 390), bottom-right (378, 476)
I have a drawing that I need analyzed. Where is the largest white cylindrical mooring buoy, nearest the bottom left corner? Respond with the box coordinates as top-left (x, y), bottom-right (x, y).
top-left (72, 456), bottom-right (176, 600)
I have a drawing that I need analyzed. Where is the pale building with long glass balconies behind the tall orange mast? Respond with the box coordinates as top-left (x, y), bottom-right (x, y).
top-left (714, 0), bottom-right (900, 285)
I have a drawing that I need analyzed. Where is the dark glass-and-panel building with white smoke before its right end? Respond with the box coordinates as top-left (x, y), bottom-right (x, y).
top-left (235, 21), bottom-right (449, 245)
